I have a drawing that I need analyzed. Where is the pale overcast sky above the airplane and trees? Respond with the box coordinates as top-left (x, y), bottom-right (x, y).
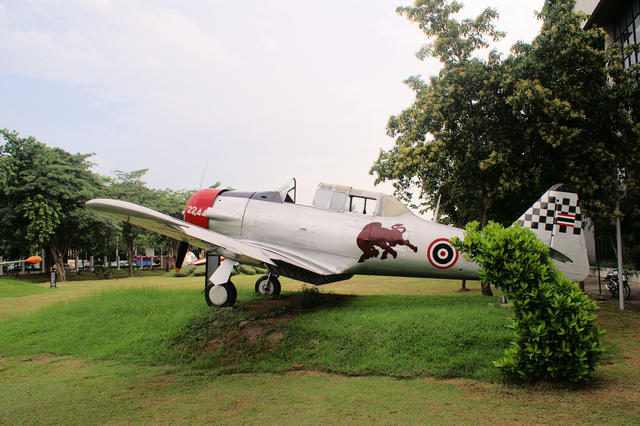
top-left (0, 0), bottom-right (544, 203)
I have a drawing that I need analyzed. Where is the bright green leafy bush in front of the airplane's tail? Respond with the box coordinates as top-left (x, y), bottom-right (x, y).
top-left (453, 222), bottom-right (604, 382)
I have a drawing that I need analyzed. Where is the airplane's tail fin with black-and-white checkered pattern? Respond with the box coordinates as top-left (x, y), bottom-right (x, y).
top-left (517, 184), bottom-right (589, 282)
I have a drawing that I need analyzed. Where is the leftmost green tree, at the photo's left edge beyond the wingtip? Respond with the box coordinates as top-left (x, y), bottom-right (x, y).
top-left (0, 129), bottom-right (99, 281)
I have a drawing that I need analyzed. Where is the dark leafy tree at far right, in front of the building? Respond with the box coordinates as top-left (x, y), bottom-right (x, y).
top-left (508, 0), bottom-right (640, 221)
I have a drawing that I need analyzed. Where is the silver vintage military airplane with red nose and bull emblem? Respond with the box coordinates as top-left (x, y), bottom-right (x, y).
top-left (87, 179), bottom-right (589, 306)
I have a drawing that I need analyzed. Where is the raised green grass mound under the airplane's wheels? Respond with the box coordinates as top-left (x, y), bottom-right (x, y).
top-left (0, 280), bottom-right (510, 380)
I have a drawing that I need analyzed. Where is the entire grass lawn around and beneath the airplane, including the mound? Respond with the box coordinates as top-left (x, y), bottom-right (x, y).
top-left (0, 275), bottom-right (640, 424)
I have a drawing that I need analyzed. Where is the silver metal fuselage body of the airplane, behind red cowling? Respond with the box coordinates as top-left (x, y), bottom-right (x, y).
top-left (206, 193), bottom-right (479, 279)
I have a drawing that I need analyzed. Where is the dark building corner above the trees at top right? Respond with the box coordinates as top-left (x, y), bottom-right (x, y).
top-left (575, 0), bottom-right (640, 67)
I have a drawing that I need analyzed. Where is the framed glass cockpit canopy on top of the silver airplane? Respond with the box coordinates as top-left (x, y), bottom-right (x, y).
top-left (313, 183), bottom-right (410, 217)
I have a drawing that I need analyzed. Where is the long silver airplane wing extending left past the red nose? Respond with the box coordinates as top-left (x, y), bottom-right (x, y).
top-left (86, 198), bottom-right (274, 265)
